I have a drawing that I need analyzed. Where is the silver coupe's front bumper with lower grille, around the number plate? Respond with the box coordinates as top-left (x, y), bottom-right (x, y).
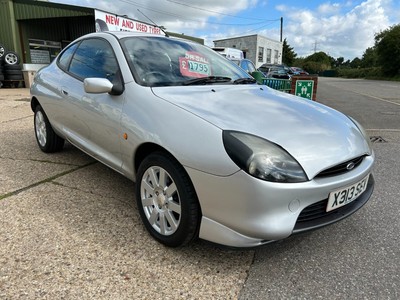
top-left (187, 156), bottom-right (374, 247)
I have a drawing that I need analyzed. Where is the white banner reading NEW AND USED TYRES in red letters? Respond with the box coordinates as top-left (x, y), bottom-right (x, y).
top-left (94, 10), bottom-right (164, 35)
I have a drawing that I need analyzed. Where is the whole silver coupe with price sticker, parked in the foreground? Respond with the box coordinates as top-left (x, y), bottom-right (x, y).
top-left (31, 32), bottom-right (374, 247)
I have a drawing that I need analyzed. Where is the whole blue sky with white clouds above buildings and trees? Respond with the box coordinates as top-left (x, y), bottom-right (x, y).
top-left (50, 0), bottom-right (400, 60)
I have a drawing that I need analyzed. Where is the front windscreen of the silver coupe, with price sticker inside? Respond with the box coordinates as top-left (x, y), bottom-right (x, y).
top-left (121, 36), bottom-right (251, 86)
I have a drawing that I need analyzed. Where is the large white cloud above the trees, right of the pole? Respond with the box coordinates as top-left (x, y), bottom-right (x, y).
top-left (277, 0), bottom-right (390, 60)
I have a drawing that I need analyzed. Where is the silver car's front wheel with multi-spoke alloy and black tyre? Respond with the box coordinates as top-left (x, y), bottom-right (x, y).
top-left (136, 152), bottom-right (201, 247)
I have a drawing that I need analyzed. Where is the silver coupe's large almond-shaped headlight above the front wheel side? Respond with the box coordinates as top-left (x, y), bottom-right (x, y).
top-left (223, 131), bottom-right (308, 183)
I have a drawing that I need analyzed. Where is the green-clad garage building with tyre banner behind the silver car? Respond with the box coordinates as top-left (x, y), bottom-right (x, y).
top-left (0, 0), bottom-right (204, 69)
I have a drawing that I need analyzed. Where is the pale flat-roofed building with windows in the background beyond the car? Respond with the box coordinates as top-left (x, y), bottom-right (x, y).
top-left (214, 34), bottom-right (283, 68)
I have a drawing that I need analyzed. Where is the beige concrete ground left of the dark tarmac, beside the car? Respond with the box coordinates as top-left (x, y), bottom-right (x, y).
top-left (0, 88), bottom-right (254, 300)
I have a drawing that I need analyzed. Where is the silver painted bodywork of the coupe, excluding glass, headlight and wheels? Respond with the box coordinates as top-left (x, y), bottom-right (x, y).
top-left (31, 33), bottom-right (374, 247)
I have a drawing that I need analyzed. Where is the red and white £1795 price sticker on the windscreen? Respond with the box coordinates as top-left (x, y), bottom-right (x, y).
top-left (179, 52), bottom-right (211, 77)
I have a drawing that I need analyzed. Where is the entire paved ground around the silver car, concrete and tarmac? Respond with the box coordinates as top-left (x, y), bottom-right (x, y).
top-left (0, 78), bottom-right (400, 300)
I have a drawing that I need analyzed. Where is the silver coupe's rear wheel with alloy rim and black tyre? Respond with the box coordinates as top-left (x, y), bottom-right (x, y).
top-left (34, 105), bottom-right (64, 153)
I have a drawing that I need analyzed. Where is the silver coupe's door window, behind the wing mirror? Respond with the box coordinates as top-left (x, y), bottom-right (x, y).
top-left (69, 39), bottom-right (118, 82)
